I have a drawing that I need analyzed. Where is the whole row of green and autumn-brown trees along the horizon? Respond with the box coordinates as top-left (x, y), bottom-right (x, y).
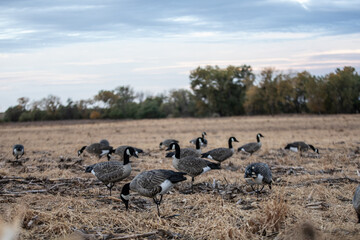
top-left (4, 65), bottom-right (360, 122)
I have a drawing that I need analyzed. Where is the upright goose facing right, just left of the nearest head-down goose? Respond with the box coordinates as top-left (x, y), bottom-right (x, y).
top-left (85, 147), bottom-right (138, 196)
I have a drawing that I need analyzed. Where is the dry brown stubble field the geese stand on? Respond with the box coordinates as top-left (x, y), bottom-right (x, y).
top-left (0, 115), bottom-right (360, 239)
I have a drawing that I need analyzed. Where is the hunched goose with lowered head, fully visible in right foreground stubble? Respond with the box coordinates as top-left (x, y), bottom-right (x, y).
top-left (244, 163), bottom-right (272, 193)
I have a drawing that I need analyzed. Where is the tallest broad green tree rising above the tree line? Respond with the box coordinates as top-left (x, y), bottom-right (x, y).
top-left (190, 65), bottom-right (254, 116)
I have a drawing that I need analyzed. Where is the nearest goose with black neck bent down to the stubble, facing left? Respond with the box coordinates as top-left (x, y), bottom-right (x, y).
top-left (120, 169), bottom-right (186, 217)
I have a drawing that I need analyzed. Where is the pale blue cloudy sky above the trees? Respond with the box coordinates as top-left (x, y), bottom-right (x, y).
top-left (0, 0), bottom-right (360, 112)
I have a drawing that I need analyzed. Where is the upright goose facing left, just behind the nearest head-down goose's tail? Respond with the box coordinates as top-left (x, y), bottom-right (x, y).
top-left (166, 143), bottom-right (221, 192)
